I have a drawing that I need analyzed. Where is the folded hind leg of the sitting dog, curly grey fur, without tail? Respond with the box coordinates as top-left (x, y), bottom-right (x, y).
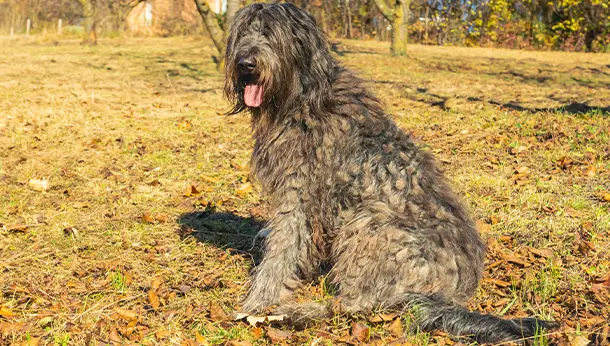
top-left (331, 214), bottom-right (460, 312)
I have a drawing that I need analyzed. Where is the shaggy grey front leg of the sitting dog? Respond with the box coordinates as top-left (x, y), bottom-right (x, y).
top-left (242, 198), bottom-right (318, 311)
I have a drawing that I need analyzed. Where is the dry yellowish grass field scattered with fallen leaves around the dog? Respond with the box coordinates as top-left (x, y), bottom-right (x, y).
top-left (0, 38), bottom-right (610, 345)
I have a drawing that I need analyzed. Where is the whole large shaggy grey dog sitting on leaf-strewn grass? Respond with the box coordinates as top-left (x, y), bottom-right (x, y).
top-left (225, 4), bottom-right (550, 342)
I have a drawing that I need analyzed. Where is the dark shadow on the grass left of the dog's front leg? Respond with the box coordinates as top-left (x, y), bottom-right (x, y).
top-left (178, 209), bottom-right (266, 263)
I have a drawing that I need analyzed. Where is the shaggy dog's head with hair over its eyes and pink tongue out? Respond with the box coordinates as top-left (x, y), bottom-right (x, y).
top-left (225, 3), bottom-right (335, 114)
